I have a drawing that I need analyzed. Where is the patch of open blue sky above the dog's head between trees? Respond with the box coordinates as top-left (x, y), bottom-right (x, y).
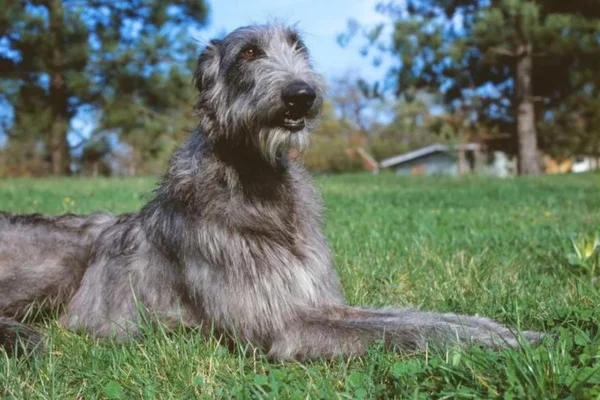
top-left (195, 0), bottom-right (394, 80)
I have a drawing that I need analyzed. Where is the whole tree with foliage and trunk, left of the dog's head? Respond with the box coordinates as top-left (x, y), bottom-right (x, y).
top-left (0, 0), bottom-right (208, 174)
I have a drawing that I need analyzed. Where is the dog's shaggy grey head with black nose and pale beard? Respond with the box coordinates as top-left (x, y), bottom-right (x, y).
top-left (195, 24), bottom-right (324, 161)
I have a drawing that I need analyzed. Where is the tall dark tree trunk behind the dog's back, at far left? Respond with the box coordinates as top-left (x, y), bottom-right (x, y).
top-left (47, 0), bottom-right (71, 175)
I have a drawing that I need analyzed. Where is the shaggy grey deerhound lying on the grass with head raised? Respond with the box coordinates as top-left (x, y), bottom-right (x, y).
top-left (0, 24), bottom-right (541, 359)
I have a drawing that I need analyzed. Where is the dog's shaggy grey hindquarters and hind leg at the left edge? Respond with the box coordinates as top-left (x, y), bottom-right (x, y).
top-left (0, 213), bottom-right (109, 353)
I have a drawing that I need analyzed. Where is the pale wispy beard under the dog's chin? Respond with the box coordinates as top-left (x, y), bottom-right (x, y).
top-left (256, 127), bottom-right (310, 164)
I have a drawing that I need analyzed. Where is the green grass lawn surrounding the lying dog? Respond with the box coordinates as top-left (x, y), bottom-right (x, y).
top-left (0, 174), bottom-right (600, 399)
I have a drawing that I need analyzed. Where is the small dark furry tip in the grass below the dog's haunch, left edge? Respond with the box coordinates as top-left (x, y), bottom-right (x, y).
top-left (0, 317), bottom-right (45, 356)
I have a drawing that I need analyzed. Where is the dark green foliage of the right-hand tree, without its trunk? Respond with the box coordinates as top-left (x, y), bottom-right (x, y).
top-left (341, 0), bottom-right (600, 162)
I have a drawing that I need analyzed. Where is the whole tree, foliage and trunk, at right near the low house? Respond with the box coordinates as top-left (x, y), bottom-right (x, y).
top-left (350, 0), bottom-right (600, 174)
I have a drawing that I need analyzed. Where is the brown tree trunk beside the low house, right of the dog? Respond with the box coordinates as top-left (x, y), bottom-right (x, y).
top-left (515, 43), bottom-right (540, 175)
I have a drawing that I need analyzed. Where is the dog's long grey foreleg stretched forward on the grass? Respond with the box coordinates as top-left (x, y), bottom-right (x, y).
top-left (269, 307), bottom-right (543, 359)
